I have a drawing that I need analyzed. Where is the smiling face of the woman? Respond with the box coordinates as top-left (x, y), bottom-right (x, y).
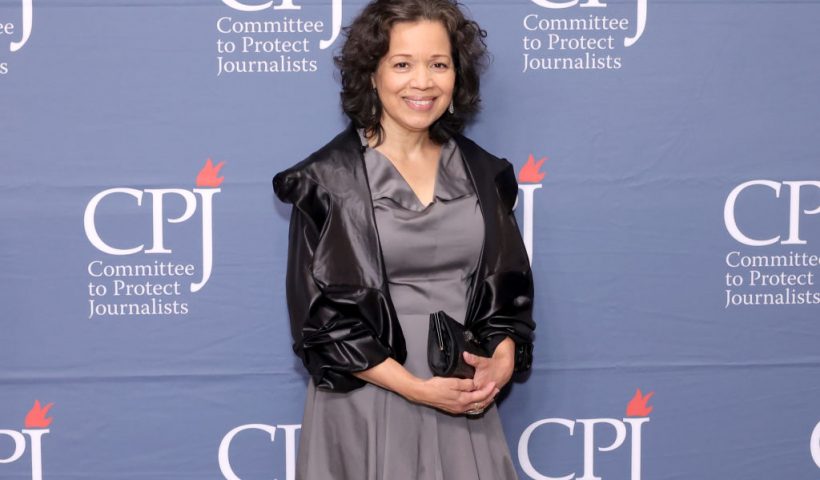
top-left (373, 20), bottom-right (456, 136)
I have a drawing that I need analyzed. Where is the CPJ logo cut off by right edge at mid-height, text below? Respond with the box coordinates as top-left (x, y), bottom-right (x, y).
top-left (723, 180), bottom-right (820, 308)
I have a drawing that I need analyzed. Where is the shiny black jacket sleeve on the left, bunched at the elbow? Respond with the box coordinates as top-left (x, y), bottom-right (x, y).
top-left (273, 174), bottom-right (390, 392)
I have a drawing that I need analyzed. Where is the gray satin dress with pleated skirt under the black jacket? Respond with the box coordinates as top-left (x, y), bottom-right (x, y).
top-left (296, 132), bottom-right (517, 480)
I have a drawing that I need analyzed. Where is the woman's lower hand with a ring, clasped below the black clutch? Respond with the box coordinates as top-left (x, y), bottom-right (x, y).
top-left (409, 377), bottom-right (499, 415)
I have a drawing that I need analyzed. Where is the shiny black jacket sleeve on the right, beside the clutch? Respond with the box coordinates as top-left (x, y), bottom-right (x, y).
top-left (473, 162), bottom-right (535, 372)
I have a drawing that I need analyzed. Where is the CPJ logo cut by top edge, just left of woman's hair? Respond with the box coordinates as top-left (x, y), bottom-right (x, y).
top-left (216, 0), bottom-right (342, 76)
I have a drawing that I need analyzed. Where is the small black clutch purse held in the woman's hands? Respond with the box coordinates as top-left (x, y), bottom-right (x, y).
top-left (427, 310), bottom-right (489, 378)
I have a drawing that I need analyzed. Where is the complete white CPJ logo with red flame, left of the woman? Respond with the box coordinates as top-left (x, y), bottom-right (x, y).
top-left (83, 159), bottom-right (224, 318)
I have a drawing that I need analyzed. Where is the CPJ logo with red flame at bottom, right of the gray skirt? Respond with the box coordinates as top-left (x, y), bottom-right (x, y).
top-left (518, 389), bottom-right (655, 480)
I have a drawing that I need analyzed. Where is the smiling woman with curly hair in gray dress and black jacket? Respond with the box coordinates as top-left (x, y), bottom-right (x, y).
top-left (274, 0), bottom-right (535, 480)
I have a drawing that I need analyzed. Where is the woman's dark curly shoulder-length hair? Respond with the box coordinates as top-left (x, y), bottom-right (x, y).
top-left (333, 0), bottom-right (489, 144)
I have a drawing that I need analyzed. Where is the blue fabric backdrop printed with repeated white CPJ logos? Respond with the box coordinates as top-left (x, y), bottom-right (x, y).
top-left (0, 0), bottom-right (820, 480)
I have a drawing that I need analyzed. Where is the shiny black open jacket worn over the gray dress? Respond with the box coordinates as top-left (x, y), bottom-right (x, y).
top-left (273, 125), bottom-right (535, 392)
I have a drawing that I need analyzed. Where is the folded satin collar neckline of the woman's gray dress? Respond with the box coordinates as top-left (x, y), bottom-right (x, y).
top-left (358, 129), bottom-right (473, 212)
